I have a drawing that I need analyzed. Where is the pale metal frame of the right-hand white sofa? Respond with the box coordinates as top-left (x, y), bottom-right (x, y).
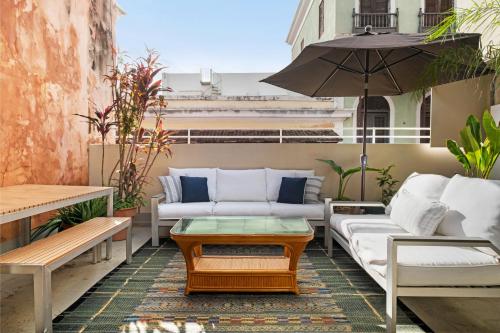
top-left (325, 201), bottom-right (500, 333)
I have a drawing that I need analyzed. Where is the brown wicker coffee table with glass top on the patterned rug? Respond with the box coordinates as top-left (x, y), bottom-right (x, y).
top-left (170, 216), bottom-right (314, 295)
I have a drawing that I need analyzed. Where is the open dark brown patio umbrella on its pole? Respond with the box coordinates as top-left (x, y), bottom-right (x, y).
top-left (262, 31), bottom-right (481, 200)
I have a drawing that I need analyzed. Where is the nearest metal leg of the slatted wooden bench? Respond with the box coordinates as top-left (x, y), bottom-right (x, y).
top-left (33, 267), bottom-right (52, 333)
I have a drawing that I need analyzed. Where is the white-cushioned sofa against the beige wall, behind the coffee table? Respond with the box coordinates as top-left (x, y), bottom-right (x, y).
top-left (151, 168), bottom-right (329, 246)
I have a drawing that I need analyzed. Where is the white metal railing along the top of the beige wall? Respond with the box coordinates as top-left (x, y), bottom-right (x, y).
top-left (164, 127), bottom-right (430, 144)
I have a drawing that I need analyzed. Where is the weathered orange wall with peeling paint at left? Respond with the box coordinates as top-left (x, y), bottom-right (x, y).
top-left (0, 0), bottom-right (116, 241)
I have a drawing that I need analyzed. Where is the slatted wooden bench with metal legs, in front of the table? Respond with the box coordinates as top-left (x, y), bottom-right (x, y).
top-left (0, 217), bottom-right (132, 333)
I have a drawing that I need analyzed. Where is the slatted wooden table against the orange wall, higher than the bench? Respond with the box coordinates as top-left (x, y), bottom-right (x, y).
top-left (0, 184), bottom-right (113, 245)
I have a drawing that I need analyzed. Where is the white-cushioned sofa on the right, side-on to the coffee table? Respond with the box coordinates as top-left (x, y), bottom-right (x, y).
top-left (328, 174), bottom-right (500, 332)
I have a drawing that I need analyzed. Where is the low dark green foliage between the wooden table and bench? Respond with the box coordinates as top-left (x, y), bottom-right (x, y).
top-left (31, 198), bottom-right (107, 241)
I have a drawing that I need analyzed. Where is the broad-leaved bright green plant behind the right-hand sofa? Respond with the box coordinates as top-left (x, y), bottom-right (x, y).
top-left (447, 111), bottom-right (500, 179)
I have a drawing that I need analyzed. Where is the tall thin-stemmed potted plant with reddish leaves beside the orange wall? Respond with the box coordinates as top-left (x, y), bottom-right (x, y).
top-left (79, 52), bottom-right (172, 240)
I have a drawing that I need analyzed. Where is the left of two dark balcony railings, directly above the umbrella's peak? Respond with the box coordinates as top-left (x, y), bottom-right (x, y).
top-left (352, 8), bottom-right (399, 34)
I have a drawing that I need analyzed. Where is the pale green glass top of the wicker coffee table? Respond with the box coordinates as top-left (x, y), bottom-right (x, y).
top-left (170, 216), bottom-right (313, 235)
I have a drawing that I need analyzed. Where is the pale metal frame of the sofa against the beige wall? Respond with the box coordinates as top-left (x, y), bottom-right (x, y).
top-left (151, 193), bottom-right (332, 247)
